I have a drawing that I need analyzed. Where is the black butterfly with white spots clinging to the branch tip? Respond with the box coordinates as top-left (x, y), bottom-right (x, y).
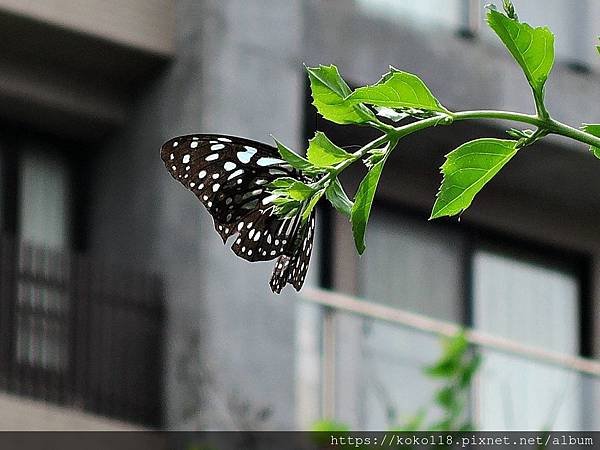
top-left (160, 134), bottom-right (315, 294)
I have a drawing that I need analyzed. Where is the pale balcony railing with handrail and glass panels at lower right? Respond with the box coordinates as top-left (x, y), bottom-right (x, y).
top-left (303, 288), bottom-right (600, 430)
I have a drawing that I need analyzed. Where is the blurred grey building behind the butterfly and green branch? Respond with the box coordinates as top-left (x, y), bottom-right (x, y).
top-left (0, 0), bottom-right (600, 430)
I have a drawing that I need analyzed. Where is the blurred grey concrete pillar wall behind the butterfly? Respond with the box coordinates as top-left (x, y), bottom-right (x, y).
top-left (92, 1), bottom-right (312, 429)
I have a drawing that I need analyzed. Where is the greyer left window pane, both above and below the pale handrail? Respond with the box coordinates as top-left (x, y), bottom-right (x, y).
top-left (335, 212), bottom-right (464, 429)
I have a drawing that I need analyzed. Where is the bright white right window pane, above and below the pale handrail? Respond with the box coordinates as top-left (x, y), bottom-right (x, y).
top-left (473, 250), bottom-right (581, 430)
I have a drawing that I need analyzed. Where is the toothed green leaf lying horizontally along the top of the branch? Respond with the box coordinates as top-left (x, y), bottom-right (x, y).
top-left (348, 67), bottom-right (449, 114)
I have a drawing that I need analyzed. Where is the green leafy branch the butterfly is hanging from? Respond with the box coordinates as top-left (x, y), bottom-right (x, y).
top-left (278, 0), bottom-right (600, 253)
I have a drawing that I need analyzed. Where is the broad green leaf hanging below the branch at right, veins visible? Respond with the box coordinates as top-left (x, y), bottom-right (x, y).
top-left (431, 138), bottom-right (517, 219)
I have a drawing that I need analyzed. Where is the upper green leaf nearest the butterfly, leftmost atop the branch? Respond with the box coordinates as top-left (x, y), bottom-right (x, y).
top-left (306, 65), bottom-right (377, 125)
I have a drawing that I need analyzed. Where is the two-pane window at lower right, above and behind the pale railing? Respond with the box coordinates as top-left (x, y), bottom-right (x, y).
top-left (326, 205), bottom-right (589, 430)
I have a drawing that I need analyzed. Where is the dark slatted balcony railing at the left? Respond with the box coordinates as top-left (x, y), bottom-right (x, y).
top-left (0, 236), bottom-right (164, 426)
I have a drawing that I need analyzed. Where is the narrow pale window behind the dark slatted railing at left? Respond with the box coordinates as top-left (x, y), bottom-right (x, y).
top-left (16, 142), bottom-right (70, 370)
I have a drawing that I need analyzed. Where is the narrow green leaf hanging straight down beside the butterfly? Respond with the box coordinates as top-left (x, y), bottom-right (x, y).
top-left (350, 158), bottom-right (387, 255)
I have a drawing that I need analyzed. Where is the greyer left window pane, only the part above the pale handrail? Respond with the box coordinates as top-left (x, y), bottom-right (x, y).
top-left (361, 210), bottom-right (464, 322)
